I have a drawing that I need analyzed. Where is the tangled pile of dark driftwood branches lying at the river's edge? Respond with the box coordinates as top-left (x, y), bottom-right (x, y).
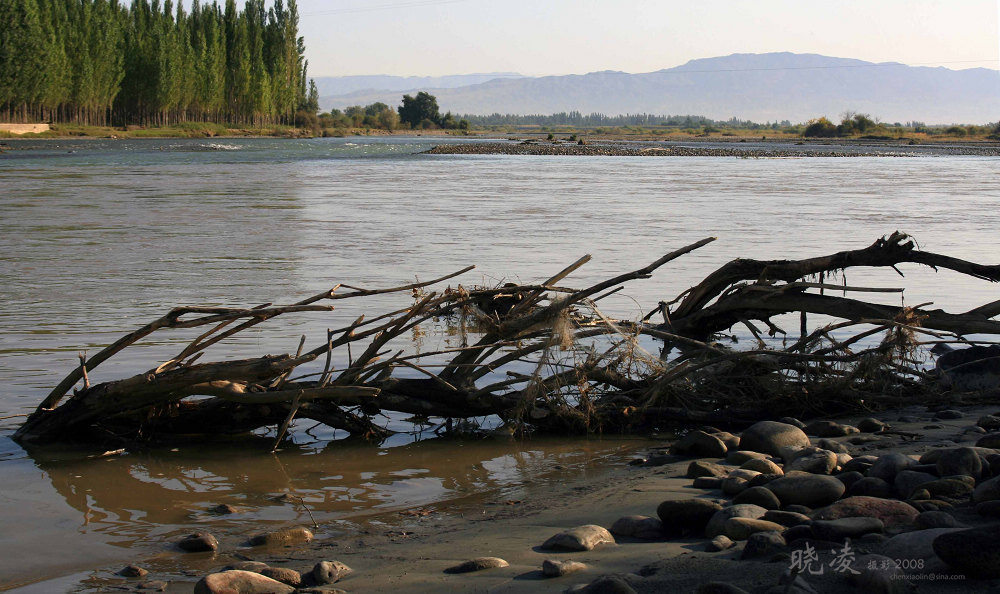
top-left (15, 232), bottom-right (1000, 445)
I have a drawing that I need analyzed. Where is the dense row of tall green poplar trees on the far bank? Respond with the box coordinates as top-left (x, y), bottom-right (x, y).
top-left (0, 0), bottom-right (318, 126)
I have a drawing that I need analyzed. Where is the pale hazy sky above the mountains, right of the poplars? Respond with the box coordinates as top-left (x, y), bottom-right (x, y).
top-left (298, 0), bottom-right (1000, 76)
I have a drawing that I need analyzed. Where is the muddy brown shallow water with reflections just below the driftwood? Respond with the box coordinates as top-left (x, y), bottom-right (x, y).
top-left (32, 437), bottom-right (638, 546)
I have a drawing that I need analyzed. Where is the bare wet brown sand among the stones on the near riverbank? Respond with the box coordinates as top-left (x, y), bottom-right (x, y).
top-left (60, 406), bottom-right (1000, 593)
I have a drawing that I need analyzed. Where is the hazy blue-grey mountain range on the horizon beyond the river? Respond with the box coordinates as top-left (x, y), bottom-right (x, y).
top-left (317, 52), bottom-right (1000, 124)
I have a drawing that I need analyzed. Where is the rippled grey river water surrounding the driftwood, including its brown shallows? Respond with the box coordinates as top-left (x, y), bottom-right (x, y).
top-left (0, 137), bottom-right (1000, 587)
